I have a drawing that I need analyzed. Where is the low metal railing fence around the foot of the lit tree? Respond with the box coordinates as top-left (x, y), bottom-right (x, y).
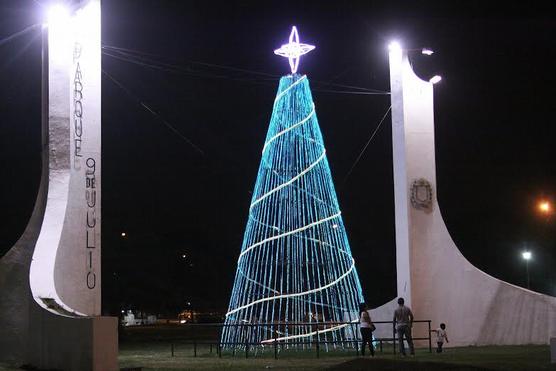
top-left (149, 320), bottom-right (432, 359)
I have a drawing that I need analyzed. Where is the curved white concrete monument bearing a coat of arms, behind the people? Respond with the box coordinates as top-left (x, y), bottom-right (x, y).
top-left (374, 47), bottom-right (556, 346)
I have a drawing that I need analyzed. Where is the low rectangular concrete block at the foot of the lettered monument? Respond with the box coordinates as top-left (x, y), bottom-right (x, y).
top-left (29, 309), bottom-right (118, 371)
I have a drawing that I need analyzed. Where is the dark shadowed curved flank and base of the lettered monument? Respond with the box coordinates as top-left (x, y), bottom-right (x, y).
top-left (0, 174), bottom-right (118, 371)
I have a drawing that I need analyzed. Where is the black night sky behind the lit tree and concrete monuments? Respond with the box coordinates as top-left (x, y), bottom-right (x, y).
top-left (0, 0), bottom-right (556, 313)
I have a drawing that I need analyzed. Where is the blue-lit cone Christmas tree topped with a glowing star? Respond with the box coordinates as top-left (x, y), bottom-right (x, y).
top-left (222, 27), bottom-right (363, 346)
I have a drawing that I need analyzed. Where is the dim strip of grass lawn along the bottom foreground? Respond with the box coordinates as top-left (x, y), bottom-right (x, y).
top-left (119, 343), bottom-right (556, 371)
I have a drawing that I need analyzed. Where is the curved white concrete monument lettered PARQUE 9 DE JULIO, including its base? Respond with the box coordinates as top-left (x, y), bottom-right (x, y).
top-left (0, 0), bottom-right (117, 371)
